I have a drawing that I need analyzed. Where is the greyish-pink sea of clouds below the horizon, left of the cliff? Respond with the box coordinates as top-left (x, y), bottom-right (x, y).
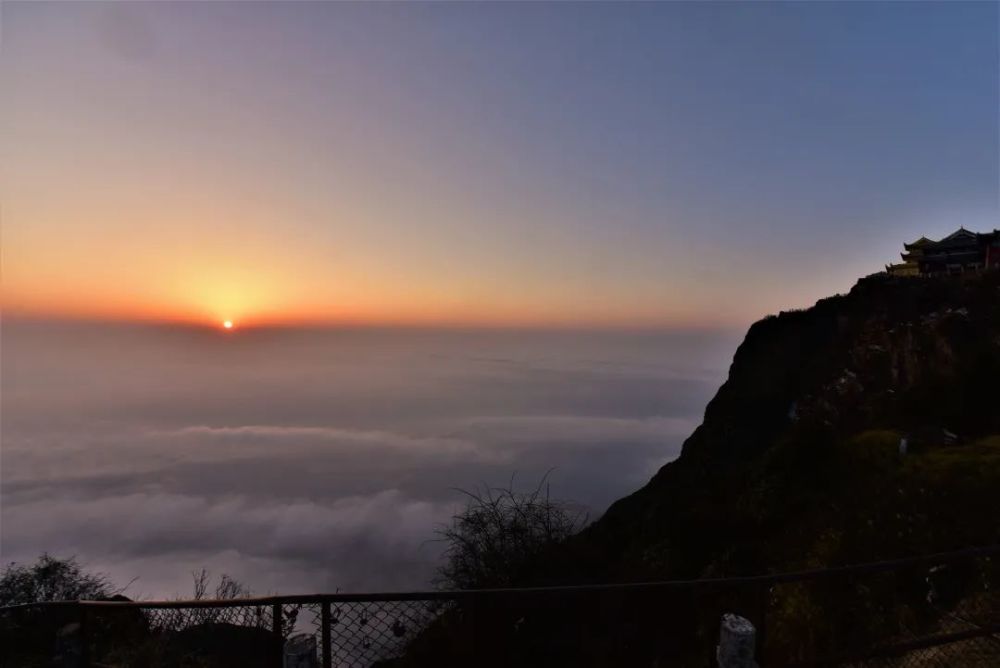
top-left (0, 322), bottom-right (737, 597)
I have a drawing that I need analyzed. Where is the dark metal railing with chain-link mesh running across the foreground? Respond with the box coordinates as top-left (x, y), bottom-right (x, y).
top-left (0, 546), bottom-right (1000, 668)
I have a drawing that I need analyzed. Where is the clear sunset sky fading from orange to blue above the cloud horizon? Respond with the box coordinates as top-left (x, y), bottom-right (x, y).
top-left (0, 2), bottom-right (1000, 326)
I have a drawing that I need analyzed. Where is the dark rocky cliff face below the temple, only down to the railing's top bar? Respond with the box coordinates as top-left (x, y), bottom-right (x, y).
top-left (563, 272), bottom-right (1000, 579)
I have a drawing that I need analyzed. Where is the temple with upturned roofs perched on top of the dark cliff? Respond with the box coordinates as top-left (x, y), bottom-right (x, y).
top-left (885, 227), bottom-right (1000, 276)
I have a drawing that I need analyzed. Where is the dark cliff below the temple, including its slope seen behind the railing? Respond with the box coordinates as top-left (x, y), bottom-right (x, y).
top-left (387, 272), bottom-right (1000, 667)
